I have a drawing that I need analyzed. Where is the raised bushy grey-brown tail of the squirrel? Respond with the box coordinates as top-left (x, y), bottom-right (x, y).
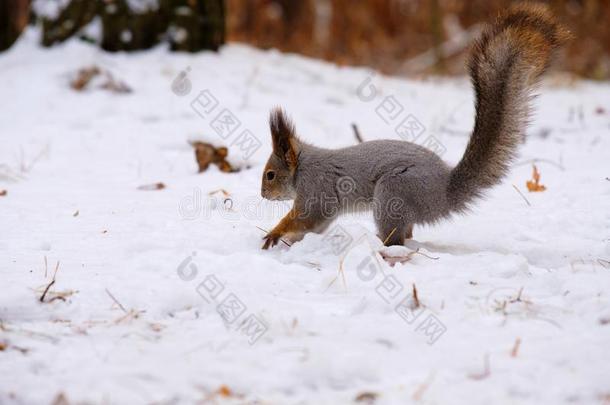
top-left (448, 3), bottom-right (570, 212)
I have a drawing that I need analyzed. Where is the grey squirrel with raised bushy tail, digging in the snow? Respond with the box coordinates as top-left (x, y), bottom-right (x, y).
top-left (261, 3), bottom-right (570, 249)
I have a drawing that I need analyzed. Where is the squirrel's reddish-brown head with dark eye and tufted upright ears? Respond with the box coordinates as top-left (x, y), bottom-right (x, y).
top-left (261, 108), bottom-right (299, 200)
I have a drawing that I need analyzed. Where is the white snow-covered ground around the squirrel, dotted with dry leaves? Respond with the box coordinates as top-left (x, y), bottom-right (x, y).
top-left (0, 32), bottom-right (610, 404)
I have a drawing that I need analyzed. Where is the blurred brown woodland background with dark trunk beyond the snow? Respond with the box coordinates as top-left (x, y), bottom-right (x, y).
top-left (0, 0), bottom-right (610, 80)
